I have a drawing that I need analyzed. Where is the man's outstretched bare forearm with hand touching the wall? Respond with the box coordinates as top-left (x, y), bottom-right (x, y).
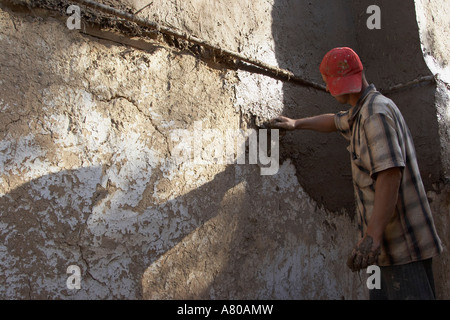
top-left (270, 114), bottom-right (337, 132)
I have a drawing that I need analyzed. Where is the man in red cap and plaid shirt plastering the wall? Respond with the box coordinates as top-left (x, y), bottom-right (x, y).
top-left (271, 48), bottom-right (442, 299)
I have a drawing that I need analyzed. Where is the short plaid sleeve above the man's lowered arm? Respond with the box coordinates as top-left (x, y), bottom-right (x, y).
top-left (364, 113), bottom-right (405, 176)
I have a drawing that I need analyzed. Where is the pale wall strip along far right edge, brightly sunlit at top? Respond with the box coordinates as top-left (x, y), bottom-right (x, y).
top-left (415, 0), bottom-right (450, 299)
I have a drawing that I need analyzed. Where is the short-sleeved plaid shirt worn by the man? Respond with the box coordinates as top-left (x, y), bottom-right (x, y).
top-left (335, 85), bottom-right (442, 266)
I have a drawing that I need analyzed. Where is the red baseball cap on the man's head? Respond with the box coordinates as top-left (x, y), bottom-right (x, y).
top-left (320, 47), bottom-right (363, 96)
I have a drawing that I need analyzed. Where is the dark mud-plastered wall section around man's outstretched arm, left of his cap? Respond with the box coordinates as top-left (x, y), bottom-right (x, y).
top-left (272, 0), bottom-right (356, 217)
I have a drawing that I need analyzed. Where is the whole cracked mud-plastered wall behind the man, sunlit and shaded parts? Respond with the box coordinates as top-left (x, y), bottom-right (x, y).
top-left (0, 0), bottom-right (450, 299)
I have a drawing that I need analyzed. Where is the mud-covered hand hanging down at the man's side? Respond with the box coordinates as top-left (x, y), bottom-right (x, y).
top-left (347, 235), bottom-right (381, 272)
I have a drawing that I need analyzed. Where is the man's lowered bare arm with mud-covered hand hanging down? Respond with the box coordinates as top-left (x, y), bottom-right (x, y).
top-left (347, 168), bottom-right (402, 271)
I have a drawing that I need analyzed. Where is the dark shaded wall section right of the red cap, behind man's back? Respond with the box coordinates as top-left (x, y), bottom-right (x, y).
top-left (353, 0), bottom-right (443, 191)
